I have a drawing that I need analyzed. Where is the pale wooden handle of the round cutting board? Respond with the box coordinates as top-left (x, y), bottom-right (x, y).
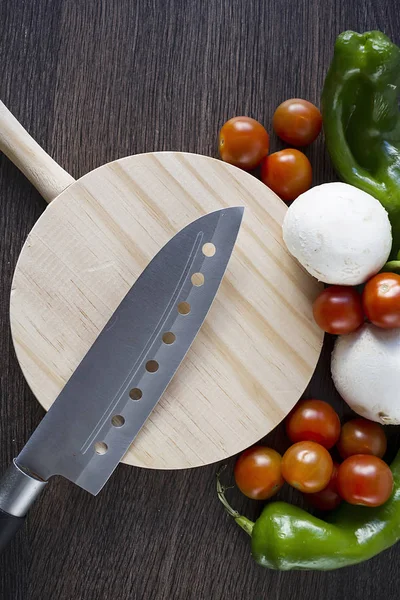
top-left (0, 101), bottom-right (75, 202)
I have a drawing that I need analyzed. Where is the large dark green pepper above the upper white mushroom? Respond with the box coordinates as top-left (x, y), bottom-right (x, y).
top-left (321, 31), bottom-right (400, 267)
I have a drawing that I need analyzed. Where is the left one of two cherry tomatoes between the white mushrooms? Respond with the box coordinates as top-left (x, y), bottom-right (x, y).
top-left (313, 285), bottom-right (364, 335)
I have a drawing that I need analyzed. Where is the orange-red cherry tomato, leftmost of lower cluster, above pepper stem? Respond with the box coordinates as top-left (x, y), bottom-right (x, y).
top-left (234, 446), bottom-right (284, 500)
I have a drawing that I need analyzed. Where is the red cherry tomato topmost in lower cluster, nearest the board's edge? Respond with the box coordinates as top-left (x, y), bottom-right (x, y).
top-left (286, 400), bottom-right (340, 449)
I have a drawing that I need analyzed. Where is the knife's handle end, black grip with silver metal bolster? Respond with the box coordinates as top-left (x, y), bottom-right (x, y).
top-left (0, 460), bottom-right (47, 552)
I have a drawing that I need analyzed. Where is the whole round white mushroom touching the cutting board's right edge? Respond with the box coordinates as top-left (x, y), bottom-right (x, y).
top-left (283, 183), bottom-right (392, 285)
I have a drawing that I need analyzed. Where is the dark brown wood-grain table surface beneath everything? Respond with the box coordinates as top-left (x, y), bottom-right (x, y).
top-left (0, 0), bottom-right (400, 600)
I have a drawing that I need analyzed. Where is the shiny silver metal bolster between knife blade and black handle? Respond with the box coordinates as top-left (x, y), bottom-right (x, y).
top-left (0, 459), bottom-right (47, 517)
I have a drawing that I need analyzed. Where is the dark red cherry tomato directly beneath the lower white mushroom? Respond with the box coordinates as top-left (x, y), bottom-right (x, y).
top-left (337, 418), bottom-right (387, 458)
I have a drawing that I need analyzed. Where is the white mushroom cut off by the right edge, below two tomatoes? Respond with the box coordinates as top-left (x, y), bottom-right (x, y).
top-left (331, 324), bottom-right (400, 425)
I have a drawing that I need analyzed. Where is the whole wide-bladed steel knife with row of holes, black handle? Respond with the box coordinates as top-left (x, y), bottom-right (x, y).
top-left (0, 207), bottom-right (244, 550)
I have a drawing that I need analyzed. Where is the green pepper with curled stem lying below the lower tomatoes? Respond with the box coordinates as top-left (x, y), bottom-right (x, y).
top-left (217, 451), bottom-right (400, 571)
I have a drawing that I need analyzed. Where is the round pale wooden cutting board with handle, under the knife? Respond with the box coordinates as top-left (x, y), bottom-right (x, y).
top-left (0, 103), bottom-right (323, 469)
